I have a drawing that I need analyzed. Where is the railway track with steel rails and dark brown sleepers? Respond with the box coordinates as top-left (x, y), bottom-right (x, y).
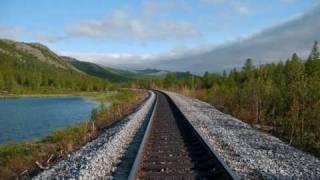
top-left (129, 92), bottom-right (238, 179)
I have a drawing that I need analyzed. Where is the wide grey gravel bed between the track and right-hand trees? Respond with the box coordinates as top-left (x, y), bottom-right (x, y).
top-left (166, 92), bottom-right (320, 179)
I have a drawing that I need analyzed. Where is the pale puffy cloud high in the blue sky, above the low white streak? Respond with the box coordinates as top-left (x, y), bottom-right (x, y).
top-left (66, 10), bottom-right (199, 41)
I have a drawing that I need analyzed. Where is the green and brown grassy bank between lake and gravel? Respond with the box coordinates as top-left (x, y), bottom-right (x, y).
top-left (0, 90), bottom-right (145, 179)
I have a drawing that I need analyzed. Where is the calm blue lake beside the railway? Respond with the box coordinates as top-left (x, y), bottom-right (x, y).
top-left (0, 97), bottom-right (99, 143)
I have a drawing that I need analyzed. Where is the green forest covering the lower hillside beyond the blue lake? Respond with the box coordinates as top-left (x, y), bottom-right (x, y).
top-left (0, 44), bottom-right (110, 94)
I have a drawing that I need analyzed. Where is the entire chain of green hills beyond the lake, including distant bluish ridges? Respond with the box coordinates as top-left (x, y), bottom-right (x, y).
top-left (0, 39), bottom-right (195, 94)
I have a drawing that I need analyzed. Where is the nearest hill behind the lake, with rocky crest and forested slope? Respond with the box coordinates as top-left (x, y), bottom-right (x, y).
top-left (0, 39), bottom-right (110, 94)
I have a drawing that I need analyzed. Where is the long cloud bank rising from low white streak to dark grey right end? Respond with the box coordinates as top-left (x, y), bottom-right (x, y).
top-left (66, 3), bottom-right (320, 73)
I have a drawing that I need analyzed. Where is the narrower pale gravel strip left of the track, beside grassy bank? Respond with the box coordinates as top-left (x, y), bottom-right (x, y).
top-left (34, 92), bottom-right (155, 179)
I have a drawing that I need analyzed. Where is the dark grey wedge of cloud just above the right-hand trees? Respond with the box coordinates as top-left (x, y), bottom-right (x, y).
top-left (158, 6), bottom-right (320, 73)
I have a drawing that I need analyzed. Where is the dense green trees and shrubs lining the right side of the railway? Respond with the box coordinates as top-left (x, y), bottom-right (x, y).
top-left (131, 42), bottom-right (320, 157)
